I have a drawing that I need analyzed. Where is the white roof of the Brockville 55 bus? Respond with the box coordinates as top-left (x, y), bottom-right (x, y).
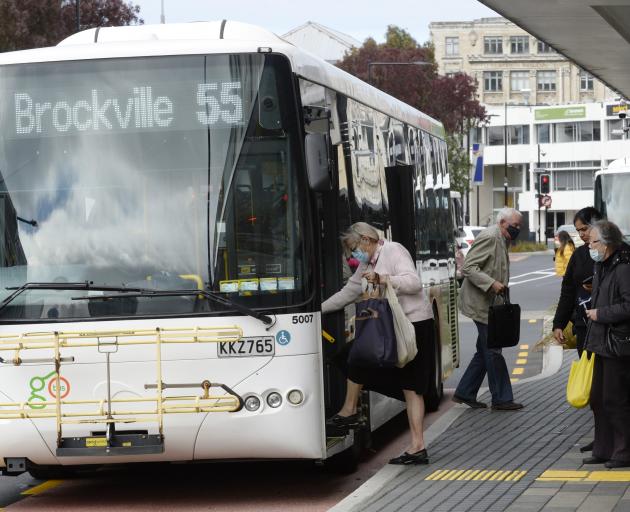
top-left (0, 20), bottom-right (444, 137)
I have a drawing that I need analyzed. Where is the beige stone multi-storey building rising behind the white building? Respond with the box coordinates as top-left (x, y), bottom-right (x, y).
top-left (429, 18), bottom-right (614, 105)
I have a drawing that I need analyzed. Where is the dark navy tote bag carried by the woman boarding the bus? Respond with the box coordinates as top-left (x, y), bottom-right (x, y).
top-left (348, 299), bottom-right (398, 368)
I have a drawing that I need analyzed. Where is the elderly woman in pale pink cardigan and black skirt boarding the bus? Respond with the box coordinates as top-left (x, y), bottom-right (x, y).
top-left (322, 222), bottom-right (435, 464)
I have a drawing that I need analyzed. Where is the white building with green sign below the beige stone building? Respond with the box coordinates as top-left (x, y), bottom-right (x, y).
top-left (470, 102), bottom-right (630, 239)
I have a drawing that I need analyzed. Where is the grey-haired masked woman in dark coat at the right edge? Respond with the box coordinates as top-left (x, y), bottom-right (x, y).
top-left (582, 220), bottom-right (630, 469)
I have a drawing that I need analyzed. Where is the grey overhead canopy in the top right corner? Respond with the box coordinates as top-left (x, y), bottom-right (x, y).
top-left (479, 0), bottom-right (630, 98)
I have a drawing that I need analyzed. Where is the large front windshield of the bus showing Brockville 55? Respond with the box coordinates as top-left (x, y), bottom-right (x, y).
top-left (0, 54), bottom-right (309, 321)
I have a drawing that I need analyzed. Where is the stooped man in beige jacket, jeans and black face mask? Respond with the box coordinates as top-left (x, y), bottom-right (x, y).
top-left (453, 208), bottom-right (523, 411)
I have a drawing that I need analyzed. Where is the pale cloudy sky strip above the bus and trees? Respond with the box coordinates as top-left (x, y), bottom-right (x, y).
top-left (131, 0), bottom-right (498, 43)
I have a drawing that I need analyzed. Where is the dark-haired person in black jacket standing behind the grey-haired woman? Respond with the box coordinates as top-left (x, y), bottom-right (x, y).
top-left (553, 206), bottom-right (602, 356)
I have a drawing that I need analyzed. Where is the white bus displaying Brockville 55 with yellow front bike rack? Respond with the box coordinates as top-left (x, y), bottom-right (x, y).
top-left (0, 21), bottom-right (459, 476)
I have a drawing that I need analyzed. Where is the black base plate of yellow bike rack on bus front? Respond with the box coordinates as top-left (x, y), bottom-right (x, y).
top-left (57, 434), bottom-right (164, 457)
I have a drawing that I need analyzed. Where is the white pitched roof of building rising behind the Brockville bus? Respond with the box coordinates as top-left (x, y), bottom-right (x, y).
top-left (282, 21), bottom-right (361, 64)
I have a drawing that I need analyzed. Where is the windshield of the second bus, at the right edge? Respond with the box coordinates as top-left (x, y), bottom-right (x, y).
top-left (595, 172), bottom-right (630, 236)
